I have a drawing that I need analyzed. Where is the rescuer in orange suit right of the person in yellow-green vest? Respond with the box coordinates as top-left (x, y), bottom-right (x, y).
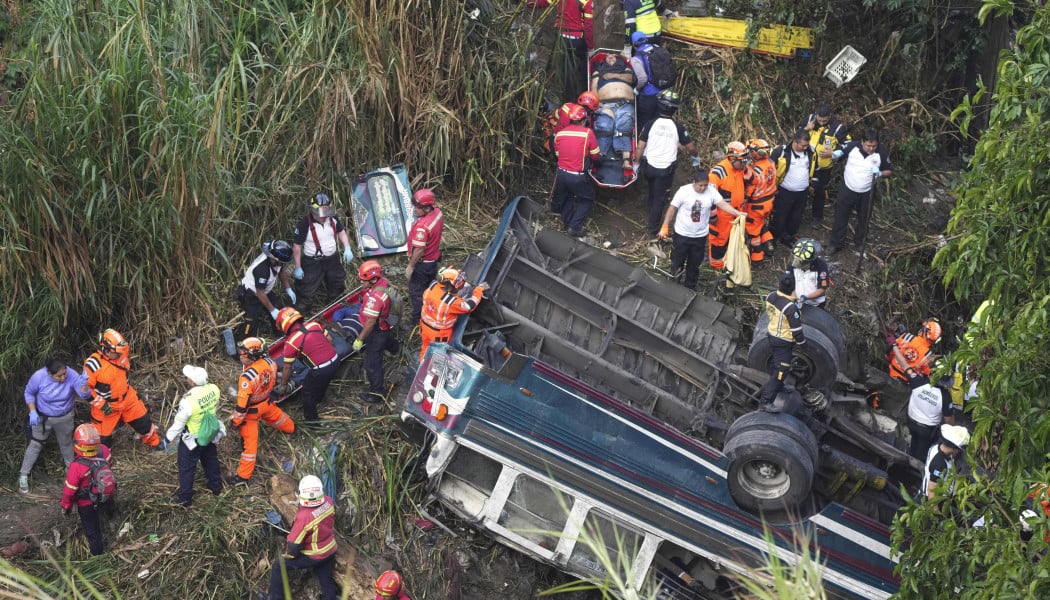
top-left (226, 336), bottom-right (295, 483)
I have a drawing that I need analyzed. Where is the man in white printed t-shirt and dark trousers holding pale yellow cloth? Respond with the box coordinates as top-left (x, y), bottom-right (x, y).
top-left (657, 169), bottom-right (743, 290)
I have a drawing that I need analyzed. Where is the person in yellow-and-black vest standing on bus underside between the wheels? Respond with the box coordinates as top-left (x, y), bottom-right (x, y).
top-left (758, 271), bottom-right (805, 409)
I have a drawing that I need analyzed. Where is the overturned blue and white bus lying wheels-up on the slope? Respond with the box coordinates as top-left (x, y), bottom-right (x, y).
top-left (402, 198), bottom-right (922, 599)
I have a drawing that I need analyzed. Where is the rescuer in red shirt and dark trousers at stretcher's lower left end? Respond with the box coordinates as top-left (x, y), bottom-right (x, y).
top-left (277, 307), bottom-right (339, 427)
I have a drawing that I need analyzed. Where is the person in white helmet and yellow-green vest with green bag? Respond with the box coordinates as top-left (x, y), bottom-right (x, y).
top-left (164, 365), bottom-right (226, 506)
